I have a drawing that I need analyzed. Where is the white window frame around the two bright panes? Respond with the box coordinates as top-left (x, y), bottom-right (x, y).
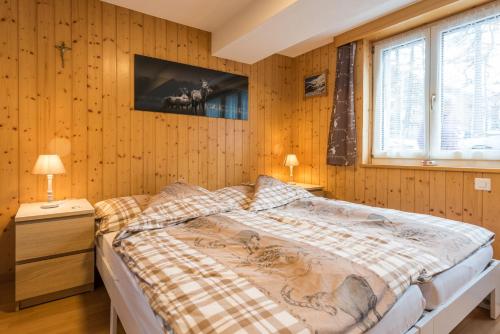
top-left (369, 3), bottom-right (500, 168)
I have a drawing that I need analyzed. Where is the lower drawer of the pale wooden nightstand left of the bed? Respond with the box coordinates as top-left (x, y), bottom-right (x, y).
top-left (16, 252), bottom-right (94, 300)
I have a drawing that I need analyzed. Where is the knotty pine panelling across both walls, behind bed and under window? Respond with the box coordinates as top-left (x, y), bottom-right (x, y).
top-left (0, 0), bottom-right (500, 288)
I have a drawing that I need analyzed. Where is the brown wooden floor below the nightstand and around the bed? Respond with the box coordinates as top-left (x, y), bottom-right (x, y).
top-left (0, 286), bottom-right (500, 334)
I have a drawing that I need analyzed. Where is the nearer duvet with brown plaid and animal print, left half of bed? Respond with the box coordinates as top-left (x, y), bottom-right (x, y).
top-left (115, 210), bottom-right (398, 333)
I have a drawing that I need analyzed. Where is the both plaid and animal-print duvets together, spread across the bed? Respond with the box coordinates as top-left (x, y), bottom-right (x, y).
top-left (114, 180), bottom-right (493, 333)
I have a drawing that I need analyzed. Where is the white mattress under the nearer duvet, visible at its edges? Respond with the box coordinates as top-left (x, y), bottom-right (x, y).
top-left (97, 232), bottom-right (425, 334)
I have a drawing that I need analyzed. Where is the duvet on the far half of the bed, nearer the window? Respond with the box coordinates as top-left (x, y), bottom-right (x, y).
top-left (260, 197), bottom-right (495, 284)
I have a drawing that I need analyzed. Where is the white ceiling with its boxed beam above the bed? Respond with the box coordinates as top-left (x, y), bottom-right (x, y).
top-left (104, 0), bottom-right (417, 64)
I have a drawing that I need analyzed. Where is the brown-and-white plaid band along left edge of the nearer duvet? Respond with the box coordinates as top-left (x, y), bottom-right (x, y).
top-left (118, 230), bottom-right (310, 333)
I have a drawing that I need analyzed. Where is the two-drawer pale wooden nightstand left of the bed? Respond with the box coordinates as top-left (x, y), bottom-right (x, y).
top-left (15, 199), bottom-right (94, 308)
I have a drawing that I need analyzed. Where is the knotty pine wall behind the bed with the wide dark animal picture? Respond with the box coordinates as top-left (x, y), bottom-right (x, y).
top-left (0, 0), bottom-right (293, 277)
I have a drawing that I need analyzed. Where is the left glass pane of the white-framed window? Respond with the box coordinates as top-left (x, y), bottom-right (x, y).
top-left (376, 39), bottom-right (426, 156)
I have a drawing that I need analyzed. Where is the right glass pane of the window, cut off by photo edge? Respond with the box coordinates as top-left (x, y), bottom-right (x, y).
top-left (439, 16), bottom-right (500, 153)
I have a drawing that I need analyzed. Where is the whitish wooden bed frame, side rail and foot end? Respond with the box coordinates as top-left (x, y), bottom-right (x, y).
top-left (96, 240), bottom-right (500, 334)
